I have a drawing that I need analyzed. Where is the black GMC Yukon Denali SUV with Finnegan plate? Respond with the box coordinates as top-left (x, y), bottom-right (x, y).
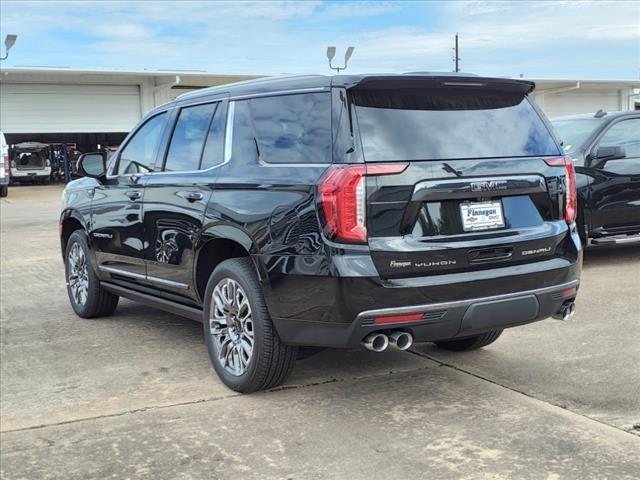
top-left (60, 74), bottom-right (582, 392)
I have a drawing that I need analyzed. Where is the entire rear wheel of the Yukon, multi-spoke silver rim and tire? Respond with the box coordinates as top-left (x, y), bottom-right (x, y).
top-left (203, 257), bottom-right (297, 393)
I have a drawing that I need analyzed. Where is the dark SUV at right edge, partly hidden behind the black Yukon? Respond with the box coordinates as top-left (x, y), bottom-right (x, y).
top-left (551, 110), bottom-right (640, 245)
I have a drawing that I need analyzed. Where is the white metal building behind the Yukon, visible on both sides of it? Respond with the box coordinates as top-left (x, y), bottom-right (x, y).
top-left (0, 67), bottom-right (640, 151)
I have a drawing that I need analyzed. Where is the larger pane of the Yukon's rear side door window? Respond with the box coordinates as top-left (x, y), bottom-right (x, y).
top-left (164, 103), bottom-right (217, 172)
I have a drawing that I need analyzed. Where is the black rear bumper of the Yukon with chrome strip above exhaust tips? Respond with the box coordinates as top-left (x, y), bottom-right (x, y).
top-left (256, 228), bottom-right (582, 347)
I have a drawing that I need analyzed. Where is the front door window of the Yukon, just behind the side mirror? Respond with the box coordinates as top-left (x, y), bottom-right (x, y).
top-left (118, 112), bottom-right (167, 175)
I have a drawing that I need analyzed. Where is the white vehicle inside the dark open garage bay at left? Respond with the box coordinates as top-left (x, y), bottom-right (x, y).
top-left (11, 142), bottom-right (51, 184)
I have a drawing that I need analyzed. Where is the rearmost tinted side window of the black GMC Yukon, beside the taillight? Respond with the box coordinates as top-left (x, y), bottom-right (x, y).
top-left (250, 92), bottom-right (331, 163)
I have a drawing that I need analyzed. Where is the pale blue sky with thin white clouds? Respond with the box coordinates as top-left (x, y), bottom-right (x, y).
top-left (0, 0), bottom-right (640, 79)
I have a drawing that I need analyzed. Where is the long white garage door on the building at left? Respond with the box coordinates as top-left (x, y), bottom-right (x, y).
top-left (0, 82), bottom-right (140, 133)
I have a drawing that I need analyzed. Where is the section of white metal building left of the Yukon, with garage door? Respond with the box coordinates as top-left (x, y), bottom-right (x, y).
top-left (0, 67), bottom-right (255, 150)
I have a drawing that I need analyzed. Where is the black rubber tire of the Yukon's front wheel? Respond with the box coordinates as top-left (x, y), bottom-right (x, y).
top-left (64, 230), bottom-right (119, 318)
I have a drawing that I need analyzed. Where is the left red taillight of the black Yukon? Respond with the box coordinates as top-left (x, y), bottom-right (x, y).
top-left (318, 163), bottom-right (407, 243)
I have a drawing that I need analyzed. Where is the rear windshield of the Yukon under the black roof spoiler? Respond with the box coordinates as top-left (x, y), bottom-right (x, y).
top-left (351, 89), bottom-right (560, 162)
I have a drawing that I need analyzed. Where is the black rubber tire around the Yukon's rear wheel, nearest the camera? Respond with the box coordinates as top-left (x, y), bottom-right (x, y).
top-left (203, 257), bottom-right (297, 393)
